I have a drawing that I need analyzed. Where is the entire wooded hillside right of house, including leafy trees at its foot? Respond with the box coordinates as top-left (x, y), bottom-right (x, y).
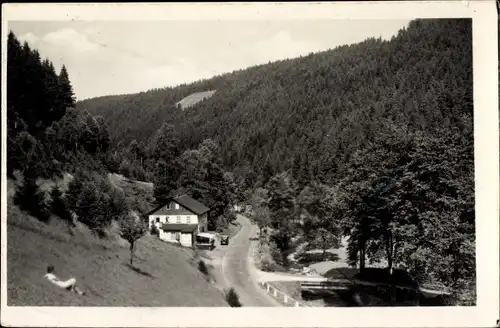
top-left (77, 19), bottom-right (475, 304)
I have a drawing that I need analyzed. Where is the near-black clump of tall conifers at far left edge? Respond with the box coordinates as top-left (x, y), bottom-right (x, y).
top-left (7, 32), bottom-right (80, 177)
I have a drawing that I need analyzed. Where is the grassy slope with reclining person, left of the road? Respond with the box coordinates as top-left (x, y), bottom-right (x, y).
top-left (7, 176), bottom-right (227, 306)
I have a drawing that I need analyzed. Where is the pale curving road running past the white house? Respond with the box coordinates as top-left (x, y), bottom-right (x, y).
top-left (222, 215), bottom-right (281, 307)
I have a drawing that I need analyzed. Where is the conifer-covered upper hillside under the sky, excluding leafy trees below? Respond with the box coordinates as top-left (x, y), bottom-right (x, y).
top-left (77, 20), bottom-right (472, 190)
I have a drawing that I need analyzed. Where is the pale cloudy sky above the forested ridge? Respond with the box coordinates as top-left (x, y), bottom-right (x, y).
top-left (8, 19), bottom-right (409, 100)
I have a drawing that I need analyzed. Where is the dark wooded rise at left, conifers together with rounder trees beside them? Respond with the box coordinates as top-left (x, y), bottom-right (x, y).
top-left (7, 32), bottom-right (110, 178)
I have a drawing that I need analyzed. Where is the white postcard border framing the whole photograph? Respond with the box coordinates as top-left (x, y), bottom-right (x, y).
top-left (1, 0), bottom-right (499, 327)
